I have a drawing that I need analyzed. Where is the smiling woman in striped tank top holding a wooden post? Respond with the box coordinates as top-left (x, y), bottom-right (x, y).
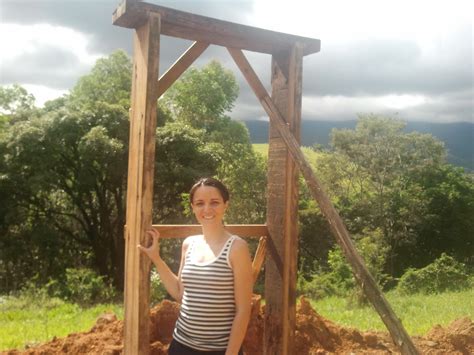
top-left (138, 178), bottom-right (253, 355)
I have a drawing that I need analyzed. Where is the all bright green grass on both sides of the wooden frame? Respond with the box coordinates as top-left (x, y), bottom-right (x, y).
top-left (0, 290), bottom-right (474, 351)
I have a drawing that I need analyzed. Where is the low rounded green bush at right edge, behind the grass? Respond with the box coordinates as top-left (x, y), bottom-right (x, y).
top-left (397, 253), bottom-right (470, 294)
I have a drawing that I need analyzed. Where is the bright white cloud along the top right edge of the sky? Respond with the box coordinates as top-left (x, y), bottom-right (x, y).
top-left (254, 0), bottom-right (474, 45)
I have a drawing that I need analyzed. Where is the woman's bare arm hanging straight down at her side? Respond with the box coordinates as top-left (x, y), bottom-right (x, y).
top-left (226, 239), bottom-right (253, 355)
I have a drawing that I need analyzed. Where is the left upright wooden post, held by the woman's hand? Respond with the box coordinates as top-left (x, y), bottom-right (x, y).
top-left (123, 14), bottom-right (160, 354)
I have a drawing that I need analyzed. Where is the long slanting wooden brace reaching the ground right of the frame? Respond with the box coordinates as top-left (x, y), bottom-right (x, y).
top-left (229, 49), bottom-right (418, 354)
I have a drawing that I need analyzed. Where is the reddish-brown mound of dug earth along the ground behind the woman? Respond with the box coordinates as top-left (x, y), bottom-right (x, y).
top-left (2, 296), bottom-right (474, 355)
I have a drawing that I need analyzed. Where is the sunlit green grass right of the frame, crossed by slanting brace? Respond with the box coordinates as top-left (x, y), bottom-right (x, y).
top-left (311, 289), bottom-right (474, 335)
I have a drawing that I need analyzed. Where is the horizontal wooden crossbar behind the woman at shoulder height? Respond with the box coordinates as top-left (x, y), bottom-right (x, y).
top-left (153, 224), bottom-right (268, 238)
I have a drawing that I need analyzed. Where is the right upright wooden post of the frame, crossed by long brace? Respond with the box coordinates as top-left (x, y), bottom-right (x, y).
top-left (264, 46), bottom-right (302, 355)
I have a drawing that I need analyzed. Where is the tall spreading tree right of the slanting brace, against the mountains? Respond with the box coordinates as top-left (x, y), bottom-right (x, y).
top-left (331, 115), bottom-right (445, 276)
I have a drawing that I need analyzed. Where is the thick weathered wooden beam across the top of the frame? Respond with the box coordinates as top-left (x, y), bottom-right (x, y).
top-left (112, 2), bottom-right (321, 55)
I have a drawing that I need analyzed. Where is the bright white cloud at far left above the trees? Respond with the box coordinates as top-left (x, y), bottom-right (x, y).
top-left (0, 23), bottom-right (99, 96)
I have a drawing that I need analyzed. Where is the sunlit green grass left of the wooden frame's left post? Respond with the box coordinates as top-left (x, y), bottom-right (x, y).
top-left (0, 297), bottom-right (123, 351)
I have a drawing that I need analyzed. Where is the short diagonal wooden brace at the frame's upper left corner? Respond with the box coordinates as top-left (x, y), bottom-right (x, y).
top-left (157, 42), bottom-right (209, 99)
